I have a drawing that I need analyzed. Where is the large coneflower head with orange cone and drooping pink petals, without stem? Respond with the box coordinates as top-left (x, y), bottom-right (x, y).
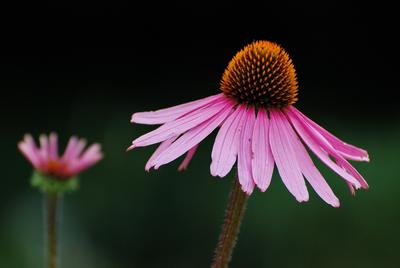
top-left (128, 41), bottom-right (369, 207)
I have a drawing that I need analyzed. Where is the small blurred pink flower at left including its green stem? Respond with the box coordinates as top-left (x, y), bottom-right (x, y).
top-left (18, 133), bottom-right (103, 268)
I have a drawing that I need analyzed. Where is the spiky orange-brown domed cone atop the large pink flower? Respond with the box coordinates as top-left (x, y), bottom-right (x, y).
top-left (221, 41), bottom-right (298, 108)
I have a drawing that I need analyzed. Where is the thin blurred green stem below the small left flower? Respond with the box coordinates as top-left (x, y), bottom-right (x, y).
top-left (44, 193), bottom-right (62, 268)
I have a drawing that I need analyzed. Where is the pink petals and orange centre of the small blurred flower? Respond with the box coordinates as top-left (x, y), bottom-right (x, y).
top-left (18, 133), bottom-right (103, 180)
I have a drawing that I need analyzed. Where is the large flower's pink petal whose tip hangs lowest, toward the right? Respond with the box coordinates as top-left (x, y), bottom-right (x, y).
top-left (285, 112), bottom-right (340, 207)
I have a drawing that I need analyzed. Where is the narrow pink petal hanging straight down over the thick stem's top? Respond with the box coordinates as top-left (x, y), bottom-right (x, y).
top-left (237, 107), bottom-right (255, 195)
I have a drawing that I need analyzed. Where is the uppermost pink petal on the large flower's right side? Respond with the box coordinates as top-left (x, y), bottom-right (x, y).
top-left (287, 106), bottom-right (369, 162)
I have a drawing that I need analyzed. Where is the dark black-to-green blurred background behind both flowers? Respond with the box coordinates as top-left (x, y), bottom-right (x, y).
top-left (0, 0), bottom-right (400, 268)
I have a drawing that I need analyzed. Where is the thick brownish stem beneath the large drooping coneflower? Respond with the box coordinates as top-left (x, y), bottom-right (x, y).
top-left (211, 177), bottom-right (247, 268)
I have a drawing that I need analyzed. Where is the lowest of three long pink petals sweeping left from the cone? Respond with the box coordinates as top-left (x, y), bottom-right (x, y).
top-left (155, 102), bottom-right (233, 169)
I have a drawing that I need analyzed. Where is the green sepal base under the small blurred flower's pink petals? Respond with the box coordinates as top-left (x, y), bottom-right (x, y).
top-left (31, 171), bottom-right (79, 194)
